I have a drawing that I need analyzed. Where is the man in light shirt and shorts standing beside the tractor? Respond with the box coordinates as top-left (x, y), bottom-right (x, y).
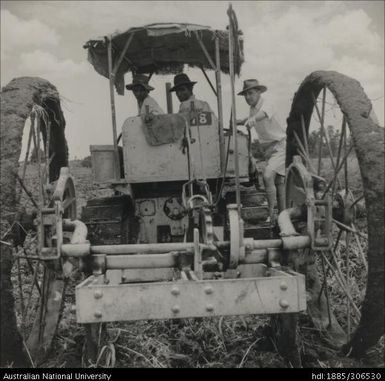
top-left (237, 79), bottom-right (286, 222)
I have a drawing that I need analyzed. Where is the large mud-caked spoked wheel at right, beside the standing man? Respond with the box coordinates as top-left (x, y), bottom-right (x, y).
top-left (286, 71), bottom-right (384, 356)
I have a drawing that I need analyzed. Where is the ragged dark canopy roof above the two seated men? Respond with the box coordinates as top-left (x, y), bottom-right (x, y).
top-left (84, 23), bottom-right (244, 95)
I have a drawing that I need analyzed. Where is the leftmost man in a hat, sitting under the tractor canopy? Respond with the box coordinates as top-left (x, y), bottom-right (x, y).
top-left (126, 74), bottom-right (164, 115)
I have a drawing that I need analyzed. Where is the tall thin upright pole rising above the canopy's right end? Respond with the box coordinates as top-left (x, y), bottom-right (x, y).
top-left (227, 4), bottom-right (241, 216)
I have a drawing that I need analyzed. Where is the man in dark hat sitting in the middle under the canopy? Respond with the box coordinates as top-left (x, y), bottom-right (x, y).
top-left (170, 73), bottom-right (213, 113)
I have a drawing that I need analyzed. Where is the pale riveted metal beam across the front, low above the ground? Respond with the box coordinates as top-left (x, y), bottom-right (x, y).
top-left (76, 269), bottom-right (306, 323)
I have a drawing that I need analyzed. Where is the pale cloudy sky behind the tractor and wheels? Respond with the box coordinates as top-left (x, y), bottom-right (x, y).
top-left (1, 0), bottom-right (384, 159)
